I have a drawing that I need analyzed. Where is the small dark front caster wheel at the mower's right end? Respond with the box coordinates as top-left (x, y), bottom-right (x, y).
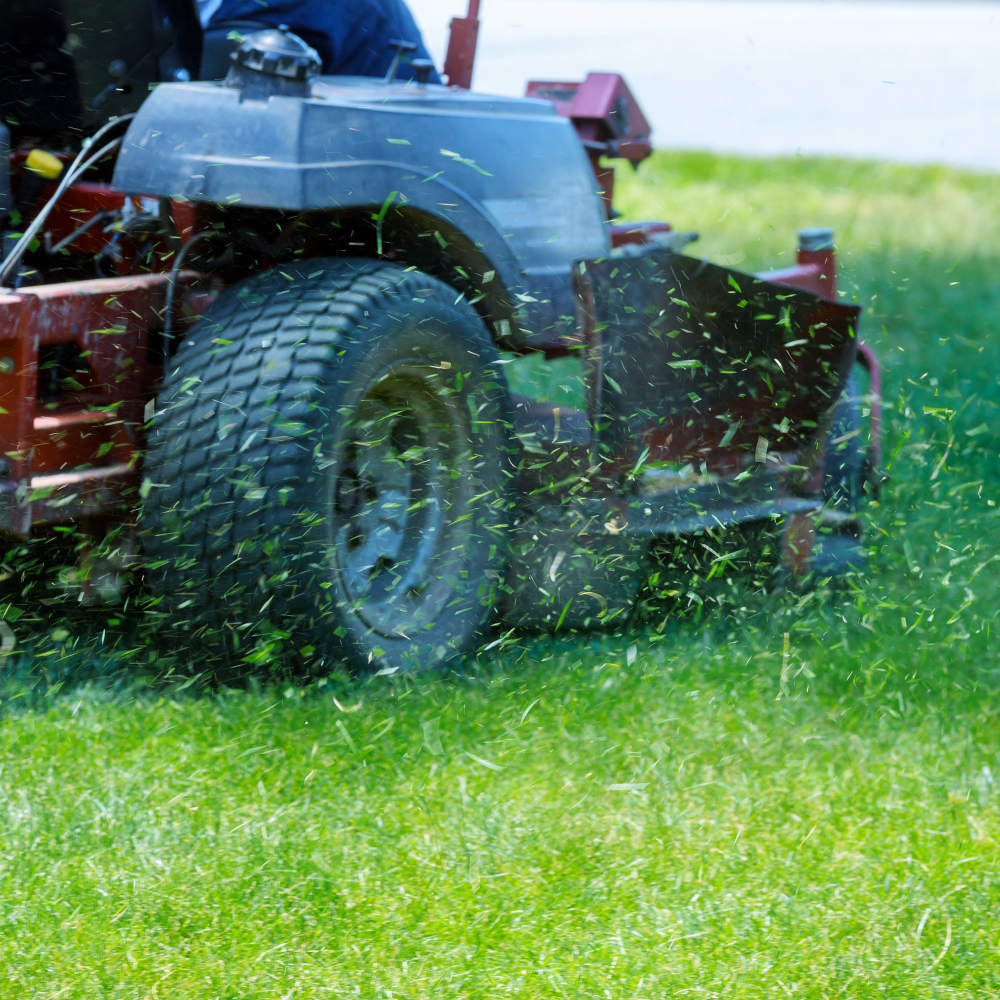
top-left (812, 368), bottom-right (868, 577)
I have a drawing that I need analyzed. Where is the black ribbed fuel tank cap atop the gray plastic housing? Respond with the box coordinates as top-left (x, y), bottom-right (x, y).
top-left (224, 24), bottom-right (322, 100)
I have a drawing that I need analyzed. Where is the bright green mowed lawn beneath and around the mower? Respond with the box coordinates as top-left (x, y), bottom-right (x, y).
top-left (0, 153), bottom-right (1000, 1000)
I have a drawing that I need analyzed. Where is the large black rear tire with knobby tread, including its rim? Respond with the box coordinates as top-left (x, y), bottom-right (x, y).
top-left (143, 259), bottom-right (515, 670)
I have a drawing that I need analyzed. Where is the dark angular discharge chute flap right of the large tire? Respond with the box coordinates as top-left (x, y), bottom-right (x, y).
top-left (577, 250), bottom-right (860, 477)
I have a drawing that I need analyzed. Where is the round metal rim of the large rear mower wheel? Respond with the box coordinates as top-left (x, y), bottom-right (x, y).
top-left (329, 362), bottom-right (472, 640)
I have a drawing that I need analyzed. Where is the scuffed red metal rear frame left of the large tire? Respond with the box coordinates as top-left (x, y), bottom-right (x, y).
top-left (0, 272), bottom-right (196, 537)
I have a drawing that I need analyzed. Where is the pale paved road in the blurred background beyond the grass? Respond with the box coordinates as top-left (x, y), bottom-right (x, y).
top-left (410, 0), bottom-right (1000, 170)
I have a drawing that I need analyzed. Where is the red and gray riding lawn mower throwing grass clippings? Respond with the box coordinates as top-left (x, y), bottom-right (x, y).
top-left (0, 0), bottom-right (879, 672)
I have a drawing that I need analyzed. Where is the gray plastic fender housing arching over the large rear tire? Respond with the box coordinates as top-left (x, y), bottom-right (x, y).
top-left (114, 77), bottom-right (610, 345)
